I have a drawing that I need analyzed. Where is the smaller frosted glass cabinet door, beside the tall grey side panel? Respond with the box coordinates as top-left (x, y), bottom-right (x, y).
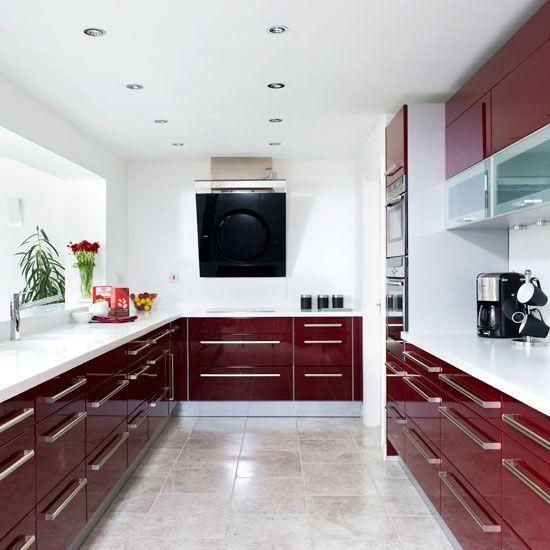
top-left (445, 161), bottom-right (490, 229)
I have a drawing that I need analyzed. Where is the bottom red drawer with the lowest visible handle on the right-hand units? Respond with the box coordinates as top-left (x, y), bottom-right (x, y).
top-left (439, 455), bottom-right (502, 550)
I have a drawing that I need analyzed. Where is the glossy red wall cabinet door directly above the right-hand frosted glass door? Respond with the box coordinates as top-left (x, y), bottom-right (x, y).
top-left (491, 42), bottom-right (550, 153)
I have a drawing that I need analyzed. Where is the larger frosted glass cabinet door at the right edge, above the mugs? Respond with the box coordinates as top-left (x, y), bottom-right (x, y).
top-left (492, 125), bottom-right (550, 216)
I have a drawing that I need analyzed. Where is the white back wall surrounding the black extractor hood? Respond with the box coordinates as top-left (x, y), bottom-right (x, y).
top-left (128, 160), bottom-right (359, 308)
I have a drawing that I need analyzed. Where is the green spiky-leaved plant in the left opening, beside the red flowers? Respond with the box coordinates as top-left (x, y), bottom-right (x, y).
top-left (15, 226), bottom-right (65, 303)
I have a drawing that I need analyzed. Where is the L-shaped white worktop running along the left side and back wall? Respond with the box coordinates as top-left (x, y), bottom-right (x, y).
top-left (0, 307), bottom-right (361, 402)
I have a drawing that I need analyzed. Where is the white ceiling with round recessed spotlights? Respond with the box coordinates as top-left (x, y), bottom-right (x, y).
top-left (0, 0), bottom-right (543, 160)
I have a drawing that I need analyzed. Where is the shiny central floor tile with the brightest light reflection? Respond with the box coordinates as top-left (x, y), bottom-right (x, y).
top-left (237, 451), bottom-right (302, 477)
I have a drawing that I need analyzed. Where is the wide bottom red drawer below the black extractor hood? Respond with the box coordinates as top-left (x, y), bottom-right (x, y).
top-left (189, 367), bottom-right (292, 401)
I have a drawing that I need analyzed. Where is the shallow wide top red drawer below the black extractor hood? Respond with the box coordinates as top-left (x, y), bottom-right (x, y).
top-left (189, 317), bottom-right (292, 335)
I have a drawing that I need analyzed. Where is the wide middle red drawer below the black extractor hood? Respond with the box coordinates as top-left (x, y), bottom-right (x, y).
top-left (189, 333), bottom-right (292, 367)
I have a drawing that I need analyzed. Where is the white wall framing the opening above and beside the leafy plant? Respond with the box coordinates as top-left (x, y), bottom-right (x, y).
top-left (0, 74), bottom-right (128, 282)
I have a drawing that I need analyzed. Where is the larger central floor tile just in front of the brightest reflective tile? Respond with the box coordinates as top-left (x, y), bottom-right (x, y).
top-left (231, 477), bottom-right (306, 514)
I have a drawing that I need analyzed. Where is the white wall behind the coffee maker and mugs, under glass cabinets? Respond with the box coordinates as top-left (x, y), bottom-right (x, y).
top-left (509, 225), bottom-right (550, 330)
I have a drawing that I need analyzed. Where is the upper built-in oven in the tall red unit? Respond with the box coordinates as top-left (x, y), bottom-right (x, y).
top-left (386, 176), bottom-right (407, 258)
